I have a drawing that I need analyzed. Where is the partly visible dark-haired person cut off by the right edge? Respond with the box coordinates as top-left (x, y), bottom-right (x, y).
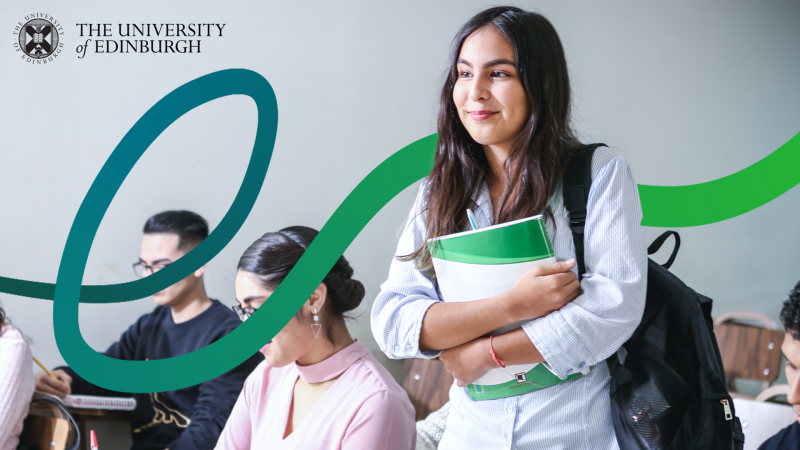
top-left (758, 282), bottom-right (800, 450)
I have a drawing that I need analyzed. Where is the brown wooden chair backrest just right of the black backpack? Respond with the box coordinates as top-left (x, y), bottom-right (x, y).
top-left (714, 323), bottom-right (784, 383)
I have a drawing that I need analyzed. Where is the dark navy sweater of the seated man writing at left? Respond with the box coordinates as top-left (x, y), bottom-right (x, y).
top-left (62, 300), bottom-right (264, 450)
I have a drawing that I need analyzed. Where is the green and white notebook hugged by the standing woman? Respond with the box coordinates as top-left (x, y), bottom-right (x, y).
top-left (428, 215), bottom-right (581, 400)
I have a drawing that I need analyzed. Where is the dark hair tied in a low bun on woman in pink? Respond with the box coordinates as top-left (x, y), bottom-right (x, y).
top-left (238, 226), bottom-right (365, 342)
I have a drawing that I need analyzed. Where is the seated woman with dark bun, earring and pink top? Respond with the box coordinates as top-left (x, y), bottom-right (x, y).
top-left (217, 226), bottom-right (416, 450)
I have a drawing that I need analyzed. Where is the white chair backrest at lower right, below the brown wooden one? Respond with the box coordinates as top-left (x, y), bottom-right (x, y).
top-left (733, 397), bottom-right (797, 450)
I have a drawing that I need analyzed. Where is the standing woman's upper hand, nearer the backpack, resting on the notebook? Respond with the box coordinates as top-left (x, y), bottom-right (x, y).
top-left (502, 258), bottom-right (581, 323)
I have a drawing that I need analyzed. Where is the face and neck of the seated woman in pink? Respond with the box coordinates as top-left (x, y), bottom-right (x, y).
top-left (236, 270), bottom-right (318, 367)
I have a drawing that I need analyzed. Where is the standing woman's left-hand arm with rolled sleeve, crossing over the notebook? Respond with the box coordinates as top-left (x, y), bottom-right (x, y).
top-left (370, 181), bottom-right (580, 359)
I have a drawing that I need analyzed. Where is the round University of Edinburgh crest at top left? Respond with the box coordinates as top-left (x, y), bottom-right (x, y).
top-left (14, 14), bottom-right (64, 64)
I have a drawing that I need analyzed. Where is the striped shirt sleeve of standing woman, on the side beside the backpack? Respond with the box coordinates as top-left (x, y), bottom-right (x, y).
top-left (522, 148), bottom-right (647, 378)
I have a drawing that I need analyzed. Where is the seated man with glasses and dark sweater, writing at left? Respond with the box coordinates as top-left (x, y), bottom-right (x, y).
top-left (35, 211), bottom-right (264, 450)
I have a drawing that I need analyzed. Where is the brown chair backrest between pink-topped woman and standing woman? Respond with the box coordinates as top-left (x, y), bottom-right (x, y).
top-left (402, 358), bottom-right (453, 420)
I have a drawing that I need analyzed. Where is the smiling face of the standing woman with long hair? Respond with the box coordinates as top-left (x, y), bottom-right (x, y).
top-left (453, 26), bottom-right (530, 148)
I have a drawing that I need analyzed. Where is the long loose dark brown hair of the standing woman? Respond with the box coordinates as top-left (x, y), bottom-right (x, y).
top-left (405, 6), bottom-right (580, 270)
